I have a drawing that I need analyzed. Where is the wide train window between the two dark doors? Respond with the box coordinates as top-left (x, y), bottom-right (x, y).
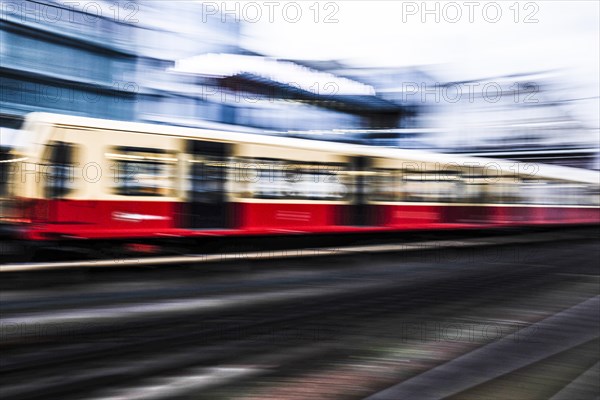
top-left (232, 159), bottom-right (348, 200)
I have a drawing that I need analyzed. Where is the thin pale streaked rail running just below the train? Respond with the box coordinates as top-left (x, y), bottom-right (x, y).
top-left (0, 226), bottom-right (597, 273)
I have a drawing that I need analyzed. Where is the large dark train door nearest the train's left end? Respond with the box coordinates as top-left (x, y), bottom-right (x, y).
top-left (182, 140), bottom-right (230, 229)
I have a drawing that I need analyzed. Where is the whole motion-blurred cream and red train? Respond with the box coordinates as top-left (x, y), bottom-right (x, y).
top-left (0, 113), bottom-right (600, 256)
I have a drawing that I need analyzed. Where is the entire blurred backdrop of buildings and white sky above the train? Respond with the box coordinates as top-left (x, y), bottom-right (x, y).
top-left (0, 0), bottom-right (600, 169)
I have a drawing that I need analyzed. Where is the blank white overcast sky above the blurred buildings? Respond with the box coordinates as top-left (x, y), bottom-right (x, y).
top-left (233, 0), bottom-right (600, 125)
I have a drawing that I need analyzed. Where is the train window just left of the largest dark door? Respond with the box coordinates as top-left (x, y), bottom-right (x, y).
top-left (106, 147), bottom-right (177, 196)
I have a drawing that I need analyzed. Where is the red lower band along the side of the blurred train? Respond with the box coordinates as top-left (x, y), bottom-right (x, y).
top-left (12, 200), bottom-right (600, 241)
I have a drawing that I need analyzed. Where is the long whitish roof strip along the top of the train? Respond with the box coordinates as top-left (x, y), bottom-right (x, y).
top-left (24, 112), bottom-right (600, 185)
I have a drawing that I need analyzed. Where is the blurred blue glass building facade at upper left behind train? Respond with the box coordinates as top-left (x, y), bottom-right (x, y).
top-left (0, 0), bottom-right (239, 126)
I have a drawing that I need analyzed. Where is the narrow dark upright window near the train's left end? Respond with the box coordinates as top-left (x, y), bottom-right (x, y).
top-left (43, 142), bottom-right (75, 198)
